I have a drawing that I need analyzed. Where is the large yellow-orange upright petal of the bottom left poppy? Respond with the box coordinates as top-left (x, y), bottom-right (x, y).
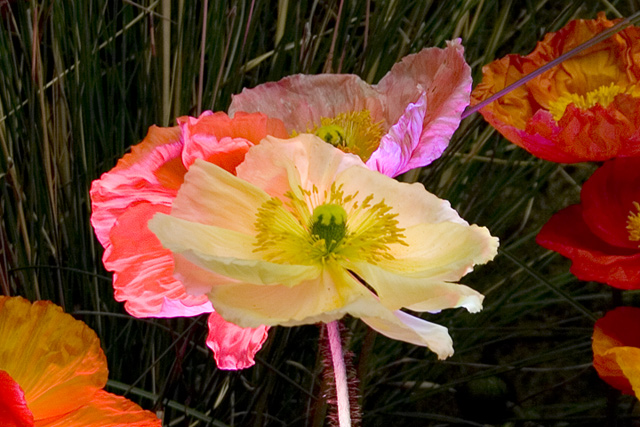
top-left (0, 297), bottom-right (108, 420)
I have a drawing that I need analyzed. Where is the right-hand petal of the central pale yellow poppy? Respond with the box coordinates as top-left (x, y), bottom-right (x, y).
top-left (378, 222), bottom-right (498, 282)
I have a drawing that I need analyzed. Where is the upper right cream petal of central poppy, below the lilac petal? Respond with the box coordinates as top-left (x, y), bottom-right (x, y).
top-left (336, 167), bottom-right (467, 228)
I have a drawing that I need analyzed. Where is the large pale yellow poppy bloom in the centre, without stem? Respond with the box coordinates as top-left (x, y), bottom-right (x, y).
top-left (149, 134), bottom-right (498, 358)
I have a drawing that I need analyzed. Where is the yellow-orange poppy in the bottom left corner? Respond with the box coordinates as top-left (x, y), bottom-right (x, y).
top-left (0, 296), bottom-right (162, 427)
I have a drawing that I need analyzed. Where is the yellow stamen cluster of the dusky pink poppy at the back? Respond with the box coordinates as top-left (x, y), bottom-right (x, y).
top-left (307, 110), bottom-right (384, 162)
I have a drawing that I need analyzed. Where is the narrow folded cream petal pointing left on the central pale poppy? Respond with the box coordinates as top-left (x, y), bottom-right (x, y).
top-left (149, 214), bottom-right (320, 288)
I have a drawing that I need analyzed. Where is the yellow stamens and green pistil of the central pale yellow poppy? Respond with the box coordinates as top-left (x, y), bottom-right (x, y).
top-left (253, 184), bottom-right (406, 265)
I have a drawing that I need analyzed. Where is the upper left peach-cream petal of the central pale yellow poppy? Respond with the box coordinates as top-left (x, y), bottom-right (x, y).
top-left (171, 159), bottom-right (271, 235)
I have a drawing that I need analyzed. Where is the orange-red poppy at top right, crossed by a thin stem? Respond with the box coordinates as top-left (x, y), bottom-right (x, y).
top-left (471, 13), bottom-right (640, 163)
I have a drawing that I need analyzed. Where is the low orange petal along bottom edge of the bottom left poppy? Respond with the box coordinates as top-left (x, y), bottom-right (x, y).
top-left (36, 390), bottom-right (162, 427)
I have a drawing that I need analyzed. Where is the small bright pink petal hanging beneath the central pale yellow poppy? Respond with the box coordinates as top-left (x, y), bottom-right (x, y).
top-left (207, 313), bottom-right (269, 370)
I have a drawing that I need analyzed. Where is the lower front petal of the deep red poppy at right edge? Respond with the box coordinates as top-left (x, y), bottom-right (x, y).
top-left (536, 205), bottom-right (640, 289)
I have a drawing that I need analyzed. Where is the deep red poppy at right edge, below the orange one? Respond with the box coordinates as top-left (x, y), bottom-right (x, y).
top-left (536, 157), bottom-right (640, 289)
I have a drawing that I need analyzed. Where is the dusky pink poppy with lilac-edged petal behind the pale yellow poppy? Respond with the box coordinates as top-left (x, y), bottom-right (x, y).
top-left (229, 40), bottom-right (472, 176)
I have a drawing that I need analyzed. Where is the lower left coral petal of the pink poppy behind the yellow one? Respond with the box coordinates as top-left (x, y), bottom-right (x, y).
top-left (103, 203), bottom-right (213, 317)
